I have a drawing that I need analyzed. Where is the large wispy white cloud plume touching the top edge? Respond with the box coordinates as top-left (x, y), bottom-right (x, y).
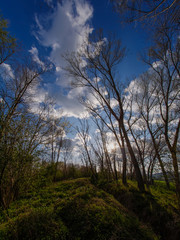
top-left (35, 0), bottom-right (93, 81)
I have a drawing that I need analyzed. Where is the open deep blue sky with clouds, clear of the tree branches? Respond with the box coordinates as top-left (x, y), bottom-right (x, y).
top-left (0, 0), bottom-right (150, 156)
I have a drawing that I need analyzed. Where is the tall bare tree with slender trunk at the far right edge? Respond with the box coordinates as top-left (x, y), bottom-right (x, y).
top-left (145, 22), bottom-right (180, 203)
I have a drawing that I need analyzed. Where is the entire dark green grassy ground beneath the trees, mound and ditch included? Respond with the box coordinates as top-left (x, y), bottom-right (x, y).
top-left (0, 178), bottom-right (180, 240)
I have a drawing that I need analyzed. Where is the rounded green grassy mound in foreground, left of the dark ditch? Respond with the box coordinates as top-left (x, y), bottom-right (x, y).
top-left (0, 179), bottom-right (159, 240)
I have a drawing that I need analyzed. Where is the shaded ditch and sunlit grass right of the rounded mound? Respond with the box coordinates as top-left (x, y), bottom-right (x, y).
top-left (97, 180), bottom-right (180, 240)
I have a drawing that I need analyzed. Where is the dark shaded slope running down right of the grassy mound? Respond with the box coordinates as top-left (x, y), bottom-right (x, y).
top-left (97, 182), bottom-right (180, 240)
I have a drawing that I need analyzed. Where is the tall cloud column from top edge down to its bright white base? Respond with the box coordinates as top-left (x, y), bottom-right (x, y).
top-left (33, 0), bottom-right (93, 118)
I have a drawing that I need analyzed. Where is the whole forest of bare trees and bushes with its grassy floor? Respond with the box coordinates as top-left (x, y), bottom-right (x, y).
top-left (0, 0), bottom-right (180, 240)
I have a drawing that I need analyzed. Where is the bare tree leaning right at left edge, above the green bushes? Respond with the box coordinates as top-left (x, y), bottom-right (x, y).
top-left (0, 62), bottom-right (48, 140)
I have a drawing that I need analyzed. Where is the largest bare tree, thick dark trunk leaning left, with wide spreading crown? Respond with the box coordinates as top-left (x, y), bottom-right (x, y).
top-left (65, 31), bottom-right (145, 191)
